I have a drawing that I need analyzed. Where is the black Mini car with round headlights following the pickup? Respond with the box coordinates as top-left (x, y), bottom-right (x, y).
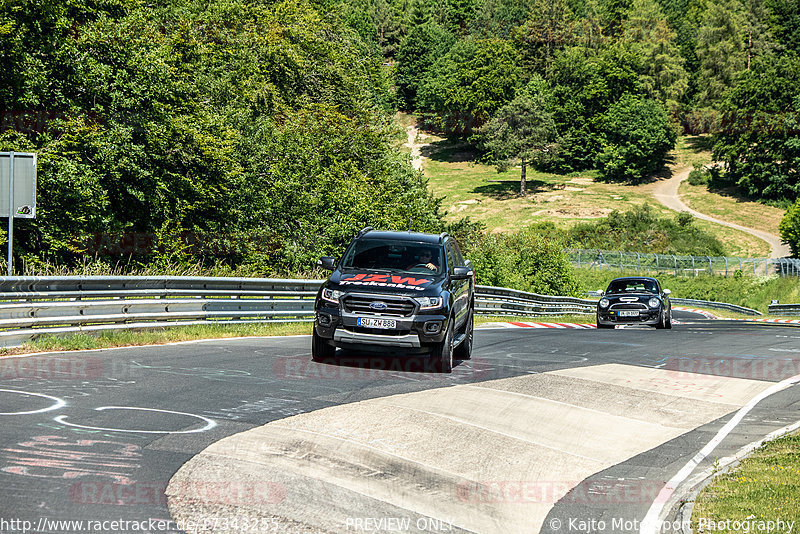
top-left (597, 276), bottom-right (672, 328)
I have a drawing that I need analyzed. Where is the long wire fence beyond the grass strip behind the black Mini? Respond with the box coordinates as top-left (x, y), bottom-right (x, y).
top-left (564, 249), bottom-right (800, 276)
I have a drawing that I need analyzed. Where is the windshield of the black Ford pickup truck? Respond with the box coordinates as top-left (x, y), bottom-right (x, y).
top-left (341, 239), bottom-right (442, 274)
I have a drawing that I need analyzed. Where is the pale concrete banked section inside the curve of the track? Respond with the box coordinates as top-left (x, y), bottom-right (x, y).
top-left (166, 364), bottom-right (771, 533)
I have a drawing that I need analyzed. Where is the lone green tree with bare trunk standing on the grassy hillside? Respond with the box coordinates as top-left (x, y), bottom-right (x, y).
top-left (479, 80), bottom-right (557, 196)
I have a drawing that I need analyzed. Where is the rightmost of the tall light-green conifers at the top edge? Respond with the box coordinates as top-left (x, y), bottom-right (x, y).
top-left (696, 0), bottom-right (747, 107)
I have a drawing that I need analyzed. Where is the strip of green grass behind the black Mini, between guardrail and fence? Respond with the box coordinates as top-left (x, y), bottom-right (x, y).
top-left (573, 268), bottom-right (800, 314)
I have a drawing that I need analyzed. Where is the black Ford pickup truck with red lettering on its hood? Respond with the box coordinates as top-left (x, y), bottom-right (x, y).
top-left (311, 228), bottom-right (475, 373)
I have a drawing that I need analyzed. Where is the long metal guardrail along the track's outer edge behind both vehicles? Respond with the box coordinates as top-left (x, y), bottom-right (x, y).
top-left (0, 276), bottom-right (780, 347)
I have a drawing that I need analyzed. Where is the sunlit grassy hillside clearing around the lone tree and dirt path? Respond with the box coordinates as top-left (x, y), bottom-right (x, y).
top-left (404, 114), bottom-right (782, 257)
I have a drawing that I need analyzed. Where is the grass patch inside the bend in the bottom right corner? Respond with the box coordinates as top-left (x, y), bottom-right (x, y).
top-left (692, 434), bottom-right (800, 534)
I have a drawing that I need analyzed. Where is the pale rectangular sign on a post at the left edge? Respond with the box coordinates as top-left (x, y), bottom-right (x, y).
top-left (0, 152), bottom-right (36, 276)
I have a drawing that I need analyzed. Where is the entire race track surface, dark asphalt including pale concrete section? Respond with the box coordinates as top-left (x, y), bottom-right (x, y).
top-left (0, 312), bottom-right (800, 533)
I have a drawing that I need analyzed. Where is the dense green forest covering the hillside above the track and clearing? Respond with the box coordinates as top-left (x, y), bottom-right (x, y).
top-left (0, 0), bottom-right (800, 282)
